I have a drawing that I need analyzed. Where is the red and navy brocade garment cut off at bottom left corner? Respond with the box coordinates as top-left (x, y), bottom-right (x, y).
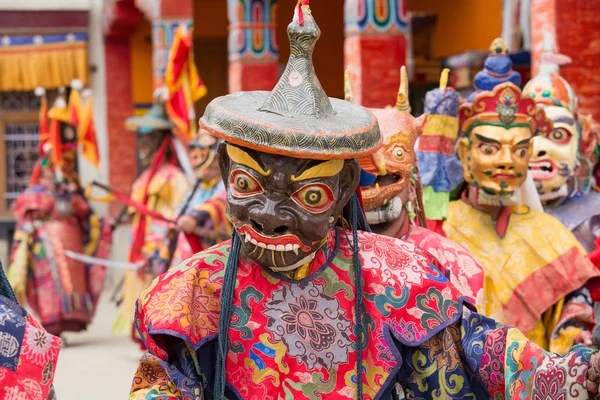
top-left (0, 292), bottom-right (60, 400)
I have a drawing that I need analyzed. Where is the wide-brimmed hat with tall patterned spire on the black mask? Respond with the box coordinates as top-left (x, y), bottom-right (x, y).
top-left (200, 5), bottom-right (381, 159)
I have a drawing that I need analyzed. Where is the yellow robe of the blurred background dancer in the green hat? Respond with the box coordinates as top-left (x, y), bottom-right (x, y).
top-left (113, 164), bottom-right (190, 335)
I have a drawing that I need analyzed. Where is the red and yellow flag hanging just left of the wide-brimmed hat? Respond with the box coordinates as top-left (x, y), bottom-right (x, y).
top-left (165, 26), bottom-right (206, 143)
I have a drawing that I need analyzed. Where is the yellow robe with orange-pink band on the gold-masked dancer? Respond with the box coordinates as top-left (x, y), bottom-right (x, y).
top-left (444, 199), bottom-right (598, 354)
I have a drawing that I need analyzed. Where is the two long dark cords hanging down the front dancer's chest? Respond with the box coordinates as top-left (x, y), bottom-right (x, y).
top-left (214, 195), bottom-right (371, 400)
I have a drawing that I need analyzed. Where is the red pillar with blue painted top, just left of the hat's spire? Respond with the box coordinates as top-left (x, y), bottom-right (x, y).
top-left (227, 0), bottom-right (279, 93)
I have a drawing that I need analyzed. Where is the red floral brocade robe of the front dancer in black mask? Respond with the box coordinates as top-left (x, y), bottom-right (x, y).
top-left (130, 230), bottom-right (593, 400)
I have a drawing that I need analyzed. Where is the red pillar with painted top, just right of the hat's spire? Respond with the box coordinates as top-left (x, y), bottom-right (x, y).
top-left (344, 0), bottom-right (409, 107)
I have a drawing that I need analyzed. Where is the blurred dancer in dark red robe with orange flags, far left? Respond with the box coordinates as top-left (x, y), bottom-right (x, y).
top-left (8, 87), bottom-right (111, 336)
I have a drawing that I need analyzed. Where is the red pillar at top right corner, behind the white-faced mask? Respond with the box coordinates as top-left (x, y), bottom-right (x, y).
top-left (531, 0), bottom-right (600, 121)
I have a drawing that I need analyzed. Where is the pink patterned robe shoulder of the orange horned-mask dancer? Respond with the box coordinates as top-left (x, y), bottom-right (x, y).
top-left (401, 225), bottom-right (483, 308)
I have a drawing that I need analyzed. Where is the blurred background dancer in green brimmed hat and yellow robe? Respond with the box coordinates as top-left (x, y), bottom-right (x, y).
top-left (114, 98), bottom-right (190, 341)
